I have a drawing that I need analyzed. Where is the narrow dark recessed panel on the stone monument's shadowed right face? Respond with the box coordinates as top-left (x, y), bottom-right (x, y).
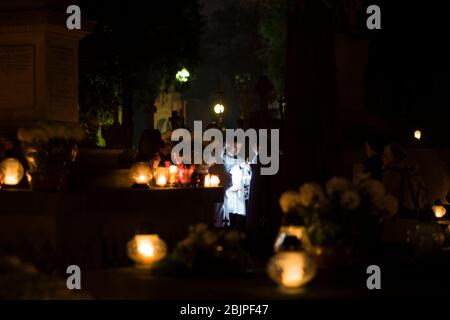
top-left (49, 46), bottom-right (76, 108)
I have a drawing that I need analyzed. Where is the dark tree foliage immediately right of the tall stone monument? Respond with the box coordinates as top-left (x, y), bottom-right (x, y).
top-left (80, 0), bottom-right (204, 146)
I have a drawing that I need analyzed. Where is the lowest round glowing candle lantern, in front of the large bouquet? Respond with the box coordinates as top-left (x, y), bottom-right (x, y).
top-left (267, 251), bottom-right (317, 288)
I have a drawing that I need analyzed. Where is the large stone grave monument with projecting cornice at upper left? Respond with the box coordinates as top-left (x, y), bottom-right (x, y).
top-left (0, 7), bottom-right (93, 135)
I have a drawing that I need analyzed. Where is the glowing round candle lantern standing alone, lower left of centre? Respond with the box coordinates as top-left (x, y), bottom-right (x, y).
top-left (127, 234), bottom-right (167, 268)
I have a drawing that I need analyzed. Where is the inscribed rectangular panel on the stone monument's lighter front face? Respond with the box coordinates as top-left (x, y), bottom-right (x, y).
top-left (0, 45), bottom-right (34, 109)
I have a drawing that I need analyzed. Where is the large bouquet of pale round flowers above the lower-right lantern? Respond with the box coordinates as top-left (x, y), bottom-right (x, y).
top-left (280, 177), bottom-right (398, 250)
